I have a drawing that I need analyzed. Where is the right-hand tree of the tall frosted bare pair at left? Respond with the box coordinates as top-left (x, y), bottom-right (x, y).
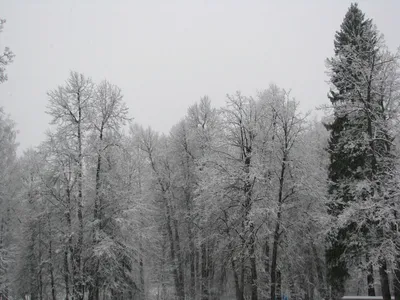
top-left (87, 81), bottom-right (129, 300)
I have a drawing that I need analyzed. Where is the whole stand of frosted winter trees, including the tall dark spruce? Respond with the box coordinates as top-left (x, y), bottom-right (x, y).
top-left (0, 4), bottom-right (400, 300)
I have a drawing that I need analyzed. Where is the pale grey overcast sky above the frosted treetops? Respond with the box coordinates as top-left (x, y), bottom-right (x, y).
top-left (0, 0), bottom-right (400, 149)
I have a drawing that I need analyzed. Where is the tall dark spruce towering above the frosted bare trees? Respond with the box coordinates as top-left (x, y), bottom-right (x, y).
top-left (326, 4), bottom-right (390, 299)
